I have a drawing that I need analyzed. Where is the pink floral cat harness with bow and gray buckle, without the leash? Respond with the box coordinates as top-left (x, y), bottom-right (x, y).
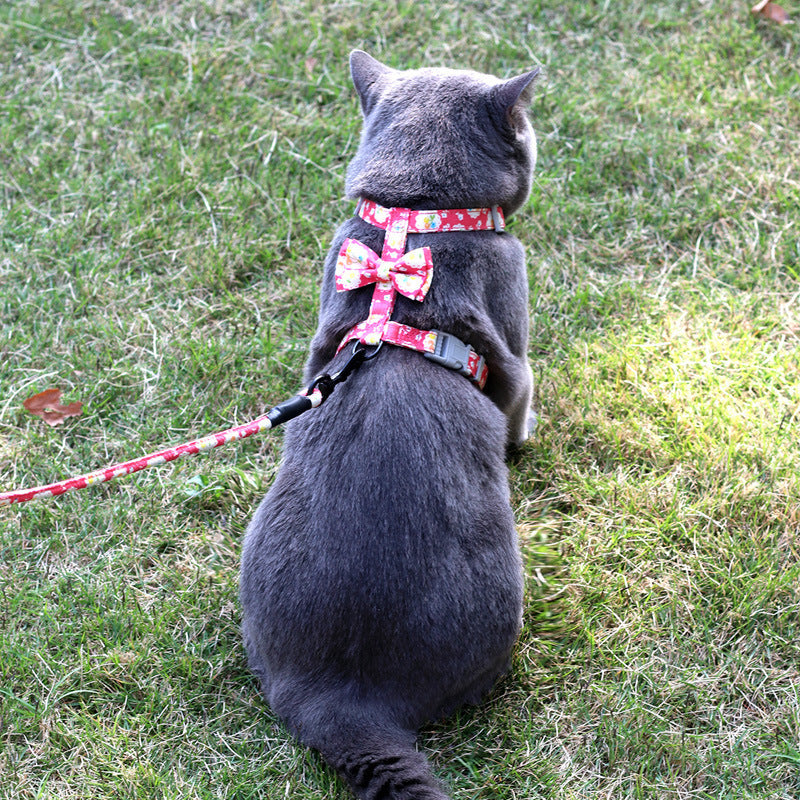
top-left (336, 198), bottom-right (505, 389)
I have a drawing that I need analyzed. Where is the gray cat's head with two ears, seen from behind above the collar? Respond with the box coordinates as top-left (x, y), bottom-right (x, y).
top-left (346, 50), bottom-right (539, 215)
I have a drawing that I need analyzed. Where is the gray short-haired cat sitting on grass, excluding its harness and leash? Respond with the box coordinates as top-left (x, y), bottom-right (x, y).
top-left (241, 51), bottom-right (537, 800)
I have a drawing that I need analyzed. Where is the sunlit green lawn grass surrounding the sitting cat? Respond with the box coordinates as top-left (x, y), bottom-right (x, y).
top-left (0, 0), bottom-right (800, 800)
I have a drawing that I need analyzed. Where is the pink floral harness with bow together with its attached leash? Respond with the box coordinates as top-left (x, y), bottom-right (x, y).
top-left (0, 200), bottom-right (505, 506)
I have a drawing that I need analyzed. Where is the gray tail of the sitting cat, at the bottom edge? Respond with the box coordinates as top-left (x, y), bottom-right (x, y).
top-left (301, 718), bottom-right (450, 800)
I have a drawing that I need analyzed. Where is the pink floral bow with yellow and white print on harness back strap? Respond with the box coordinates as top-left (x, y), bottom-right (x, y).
top-left (336, 239), bottom-right (433, 302)
